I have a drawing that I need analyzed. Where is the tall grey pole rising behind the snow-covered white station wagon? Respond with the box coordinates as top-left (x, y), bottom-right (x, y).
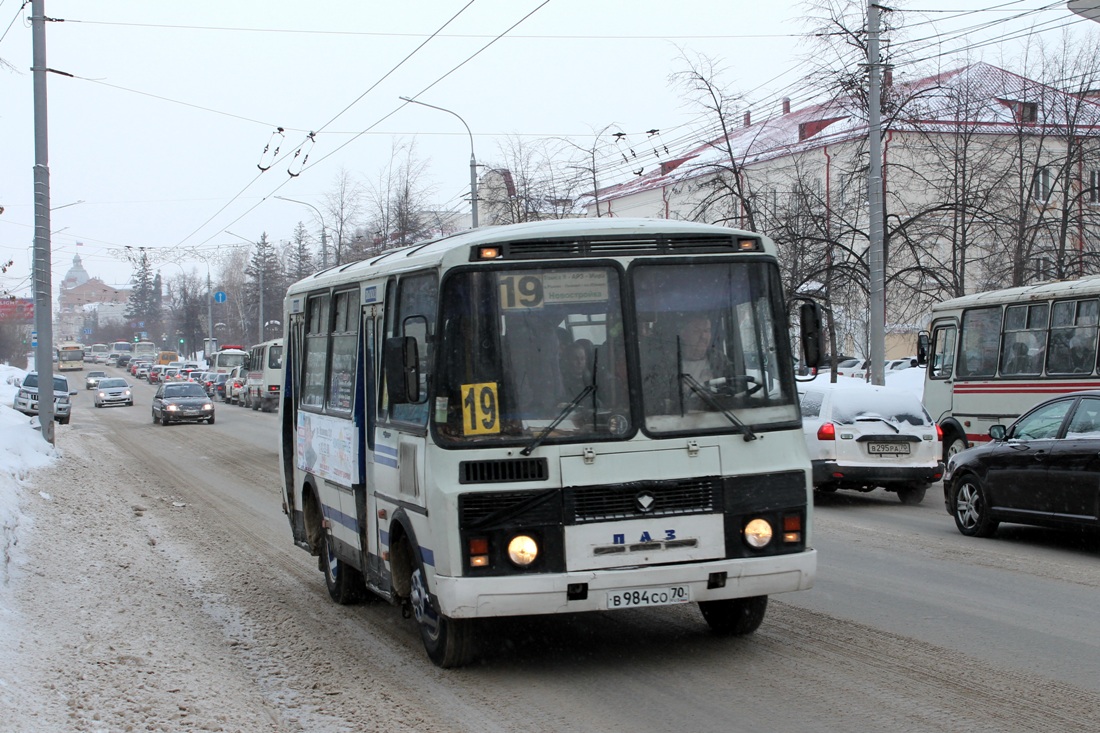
top-left (867, 0), bottom-right (887, 384)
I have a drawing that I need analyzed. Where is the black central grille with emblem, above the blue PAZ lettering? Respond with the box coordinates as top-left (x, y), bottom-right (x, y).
top-left (565, 478), bottom-right (722, 524)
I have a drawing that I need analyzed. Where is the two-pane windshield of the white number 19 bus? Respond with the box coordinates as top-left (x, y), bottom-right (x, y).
top-left (431, 261), bottom-right (799, 445)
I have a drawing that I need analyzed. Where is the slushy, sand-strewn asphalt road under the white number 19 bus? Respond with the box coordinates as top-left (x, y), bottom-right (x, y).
top-left (0, 370), bottom-right (1100, 733)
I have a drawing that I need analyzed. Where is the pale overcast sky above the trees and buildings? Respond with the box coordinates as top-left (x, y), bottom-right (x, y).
top-left (0, 0), bottom-right (1091, 296)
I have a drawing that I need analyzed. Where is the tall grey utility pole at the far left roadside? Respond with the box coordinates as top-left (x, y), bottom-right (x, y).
top-left (31, 0), bottom-right (54, 445)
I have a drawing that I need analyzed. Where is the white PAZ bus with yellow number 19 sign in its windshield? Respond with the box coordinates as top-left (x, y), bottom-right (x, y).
top-left (281, 219), bottom-right (820, 667)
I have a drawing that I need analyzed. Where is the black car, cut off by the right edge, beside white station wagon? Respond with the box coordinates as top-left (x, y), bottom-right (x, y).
top-left (944, 391), bottom-right (1100, 537)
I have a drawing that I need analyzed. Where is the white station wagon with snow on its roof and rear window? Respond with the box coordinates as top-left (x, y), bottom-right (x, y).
top-left (799, 381), bottom-right (944, 504)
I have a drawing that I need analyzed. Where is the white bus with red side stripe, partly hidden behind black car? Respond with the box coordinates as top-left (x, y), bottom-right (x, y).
top-left (921, 270), bottom-right (1100, 460)
